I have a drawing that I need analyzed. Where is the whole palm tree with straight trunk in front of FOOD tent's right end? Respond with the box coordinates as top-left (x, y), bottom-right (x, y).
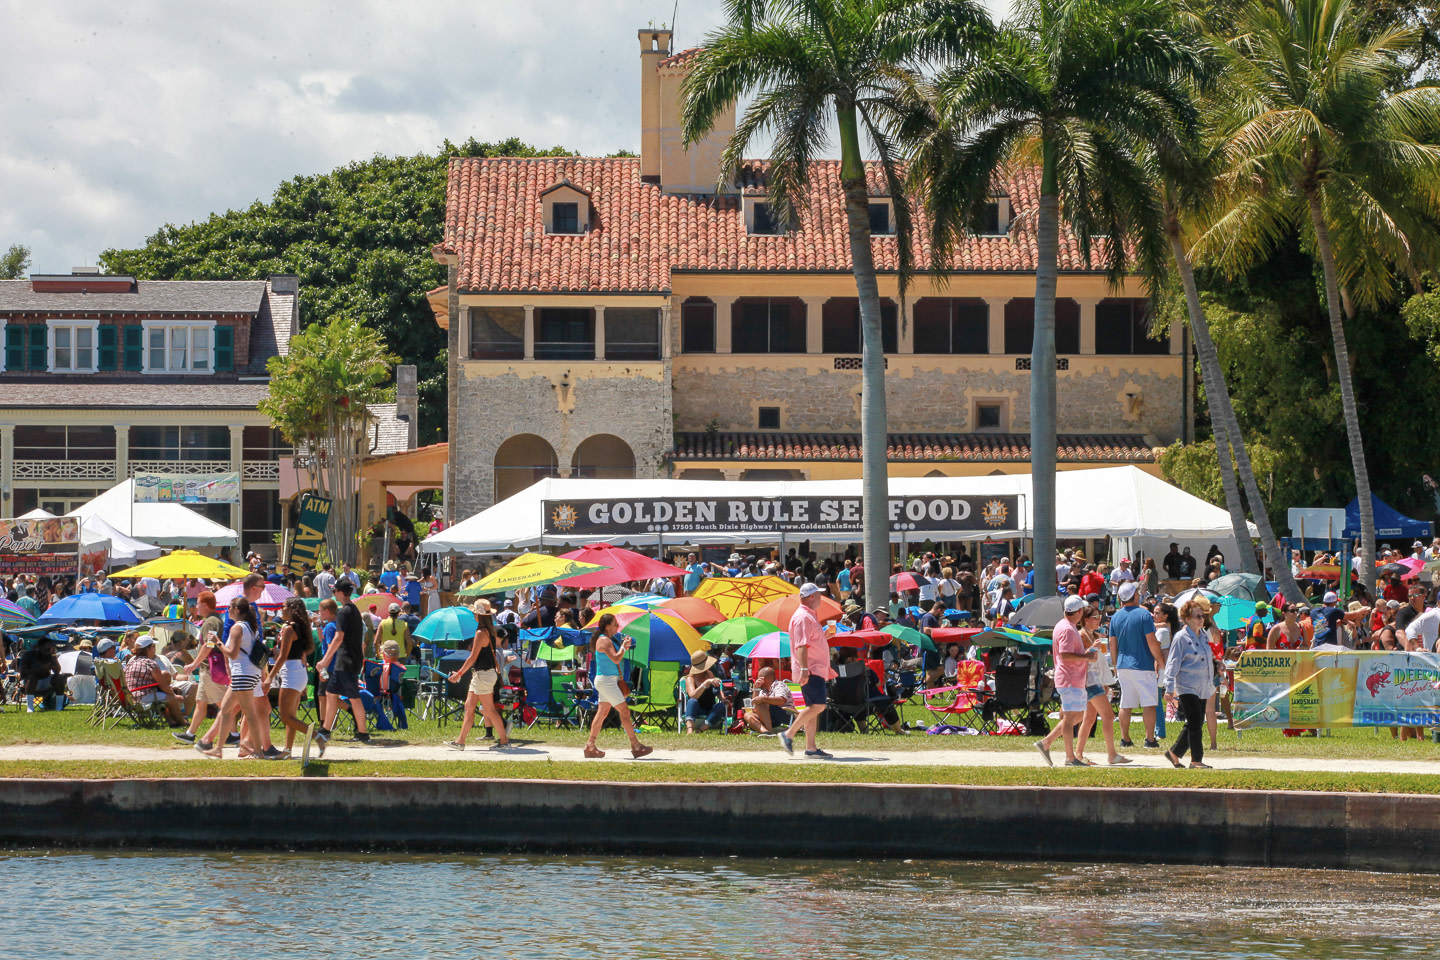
top-left (906, 0), bottom-right (1204, 594)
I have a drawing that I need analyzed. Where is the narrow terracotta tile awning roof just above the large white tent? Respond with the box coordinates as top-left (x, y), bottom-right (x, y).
top-left (672, 432), bottom-right (1155, 463)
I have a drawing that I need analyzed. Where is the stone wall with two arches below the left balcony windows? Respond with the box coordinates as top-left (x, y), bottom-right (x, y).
top-left (451, 361), bottom-right (674, 517)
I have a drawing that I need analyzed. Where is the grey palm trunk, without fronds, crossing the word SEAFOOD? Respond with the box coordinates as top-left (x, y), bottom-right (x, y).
top-left (837, 104), bottom-right (891, 603)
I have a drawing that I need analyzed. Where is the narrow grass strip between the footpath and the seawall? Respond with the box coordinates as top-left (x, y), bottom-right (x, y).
top-left (0, 760), bottom-right (1440, 794)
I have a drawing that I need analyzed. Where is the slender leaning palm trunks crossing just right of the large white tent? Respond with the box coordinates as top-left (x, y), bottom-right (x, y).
top-left (1169, 225), bottom-right (1305, 603)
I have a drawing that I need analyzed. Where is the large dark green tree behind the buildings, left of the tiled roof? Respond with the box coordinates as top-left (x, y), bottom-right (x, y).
top-left (100, 138), bottom-right (573, 443)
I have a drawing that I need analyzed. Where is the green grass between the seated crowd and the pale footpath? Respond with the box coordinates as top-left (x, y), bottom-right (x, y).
top-left (0, 704), bottom-right (1440, 760)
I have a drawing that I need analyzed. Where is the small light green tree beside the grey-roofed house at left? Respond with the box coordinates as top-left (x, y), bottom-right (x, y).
top-left (259, 314), bottom-right (396, 560)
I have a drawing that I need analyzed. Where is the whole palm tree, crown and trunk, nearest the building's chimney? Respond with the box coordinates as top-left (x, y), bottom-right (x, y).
top-left (683, 0), bottom-right (989, 596)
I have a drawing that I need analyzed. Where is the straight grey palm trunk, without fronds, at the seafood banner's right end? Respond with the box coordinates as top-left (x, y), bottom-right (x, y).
top-left (1030, 140), bottom-right (1060, 597)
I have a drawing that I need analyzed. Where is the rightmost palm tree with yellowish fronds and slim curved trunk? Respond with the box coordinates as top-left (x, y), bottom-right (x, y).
top-left (1195, 0), bottom-right (1440, 587)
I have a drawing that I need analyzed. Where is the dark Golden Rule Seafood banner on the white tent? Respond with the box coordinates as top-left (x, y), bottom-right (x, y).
top-left (543, 495), bottom-right (1020, 537)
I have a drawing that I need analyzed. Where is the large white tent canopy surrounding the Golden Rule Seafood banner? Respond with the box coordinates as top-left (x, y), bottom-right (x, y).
top-left (420, 466), bottom-right (1254, 554)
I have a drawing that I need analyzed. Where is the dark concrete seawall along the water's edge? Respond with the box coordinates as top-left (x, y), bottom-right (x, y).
top-left (0, 777), bottom-right (1440, 872)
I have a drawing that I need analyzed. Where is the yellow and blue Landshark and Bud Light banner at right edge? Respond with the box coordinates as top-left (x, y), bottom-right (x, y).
top-left (1231, 651), bottom-right (1440, 730)
